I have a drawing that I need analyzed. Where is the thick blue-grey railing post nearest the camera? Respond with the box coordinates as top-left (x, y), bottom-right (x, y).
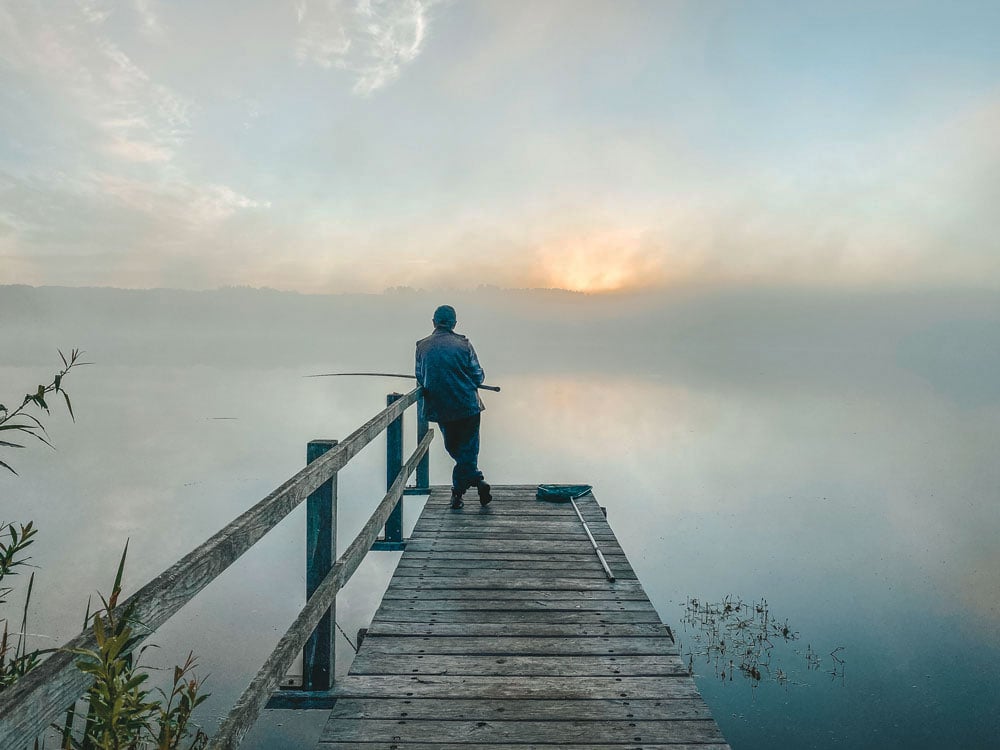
top-left (302, 440), bottom-right (337, 690)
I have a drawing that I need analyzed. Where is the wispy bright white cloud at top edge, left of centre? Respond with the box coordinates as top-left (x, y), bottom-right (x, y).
top-left (295, 0), bottom-right (438, 96)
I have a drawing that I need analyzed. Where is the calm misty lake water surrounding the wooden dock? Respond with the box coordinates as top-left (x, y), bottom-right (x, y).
top-left (0, 286), bottom-right (1000, 749)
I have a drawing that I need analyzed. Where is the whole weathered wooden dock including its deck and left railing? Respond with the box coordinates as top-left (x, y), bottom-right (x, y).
top-left (0, 387), bottom-right (728, 750)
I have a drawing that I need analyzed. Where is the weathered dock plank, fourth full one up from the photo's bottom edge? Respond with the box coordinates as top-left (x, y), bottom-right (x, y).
top-left (351, 649), bottom-right (688, 677)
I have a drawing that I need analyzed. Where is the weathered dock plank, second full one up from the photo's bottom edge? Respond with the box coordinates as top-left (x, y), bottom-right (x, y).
top-left (330, 698), bottom-right (711, 722)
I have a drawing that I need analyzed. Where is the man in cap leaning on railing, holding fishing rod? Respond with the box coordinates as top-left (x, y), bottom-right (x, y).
top-left (416, 305), bottom-right (493, 510)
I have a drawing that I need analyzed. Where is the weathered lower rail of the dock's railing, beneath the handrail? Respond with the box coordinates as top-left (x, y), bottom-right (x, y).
top-left (210, 431), bottom-right (434, 750)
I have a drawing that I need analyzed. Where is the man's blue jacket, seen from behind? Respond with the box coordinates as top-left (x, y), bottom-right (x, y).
top-left (416, 327), bottom-right (486, 422)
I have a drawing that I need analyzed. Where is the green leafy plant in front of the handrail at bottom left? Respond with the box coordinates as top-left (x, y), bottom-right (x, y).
top-left (60, 544), bottom-right (208, 750)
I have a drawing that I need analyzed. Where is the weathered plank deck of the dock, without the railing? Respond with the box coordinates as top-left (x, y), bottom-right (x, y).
top-left (319, 485), bottom-right (728, 750)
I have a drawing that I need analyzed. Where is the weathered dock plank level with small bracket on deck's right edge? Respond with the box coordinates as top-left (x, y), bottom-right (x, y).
top-left (366, 620), bottom-right (671, 642)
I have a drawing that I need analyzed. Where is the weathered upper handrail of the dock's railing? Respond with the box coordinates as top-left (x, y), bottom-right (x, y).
top-left (0, 386), bottom-right (426, 748)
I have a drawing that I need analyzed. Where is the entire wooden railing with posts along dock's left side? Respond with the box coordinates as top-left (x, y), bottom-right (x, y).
top-left (0, 388), bottom-right (434, 750)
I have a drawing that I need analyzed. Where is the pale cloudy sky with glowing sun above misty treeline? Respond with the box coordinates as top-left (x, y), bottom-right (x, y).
top-left (0, 0), bottom-right (1000, 293)
